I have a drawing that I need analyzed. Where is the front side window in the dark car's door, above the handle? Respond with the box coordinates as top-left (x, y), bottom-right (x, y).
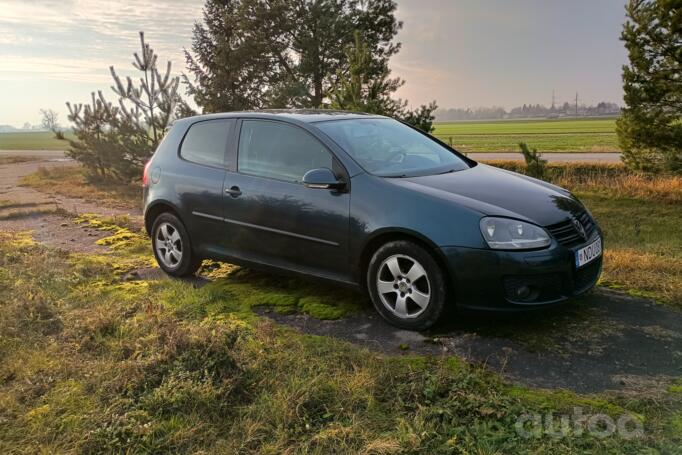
top-left (237, 120), bottom-right (333, 183)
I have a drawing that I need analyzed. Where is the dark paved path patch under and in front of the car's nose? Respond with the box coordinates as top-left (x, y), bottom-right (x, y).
top-left (268, 289), bottom-right (682, 395)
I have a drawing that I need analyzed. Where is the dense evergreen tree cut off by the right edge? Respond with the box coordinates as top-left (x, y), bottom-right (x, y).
top-left (617, 0), bottom-right (682, 173)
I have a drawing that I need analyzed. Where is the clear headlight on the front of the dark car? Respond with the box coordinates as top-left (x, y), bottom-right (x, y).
top-left (480, 217), bottom-right (552, 250)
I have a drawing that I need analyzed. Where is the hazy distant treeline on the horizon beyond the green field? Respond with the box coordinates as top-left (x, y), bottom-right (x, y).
top-left (435, 102), bottom-right (620, 122)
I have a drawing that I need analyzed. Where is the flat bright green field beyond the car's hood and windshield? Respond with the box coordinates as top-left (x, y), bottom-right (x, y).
top-left (433, 119), bottom-right (619, 152)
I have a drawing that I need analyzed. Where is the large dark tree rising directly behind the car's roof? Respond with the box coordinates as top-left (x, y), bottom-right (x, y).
top-left (185, 0), bottom-right (402, 112)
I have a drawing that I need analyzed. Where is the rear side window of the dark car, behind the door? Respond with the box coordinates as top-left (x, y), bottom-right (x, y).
top-left (180, 119), bottom-right (235, 167)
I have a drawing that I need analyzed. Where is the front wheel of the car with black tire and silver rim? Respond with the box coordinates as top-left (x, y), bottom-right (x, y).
top-left (367, 240), bottom-right (448, 330)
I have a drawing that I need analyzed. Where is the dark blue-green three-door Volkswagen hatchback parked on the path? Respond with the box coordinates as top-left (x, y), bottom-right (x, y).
top-left (143, 111), bottom-right (602, 330)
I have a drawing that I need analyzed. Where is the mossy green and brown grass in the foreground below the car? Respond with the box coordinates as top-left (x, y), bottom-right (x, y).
top-left (0, 224), bottom-right (682, 454)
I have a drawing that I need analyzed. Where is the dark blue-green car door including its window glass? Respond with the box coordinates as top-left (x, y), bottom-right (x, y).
top-left (223, 119), bottom-right (350, 279)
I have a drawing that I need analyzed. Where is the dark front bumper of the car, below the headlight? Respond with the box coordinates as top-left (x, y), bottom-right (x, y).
top-left (441, 230), bottom-right (603, 311)
